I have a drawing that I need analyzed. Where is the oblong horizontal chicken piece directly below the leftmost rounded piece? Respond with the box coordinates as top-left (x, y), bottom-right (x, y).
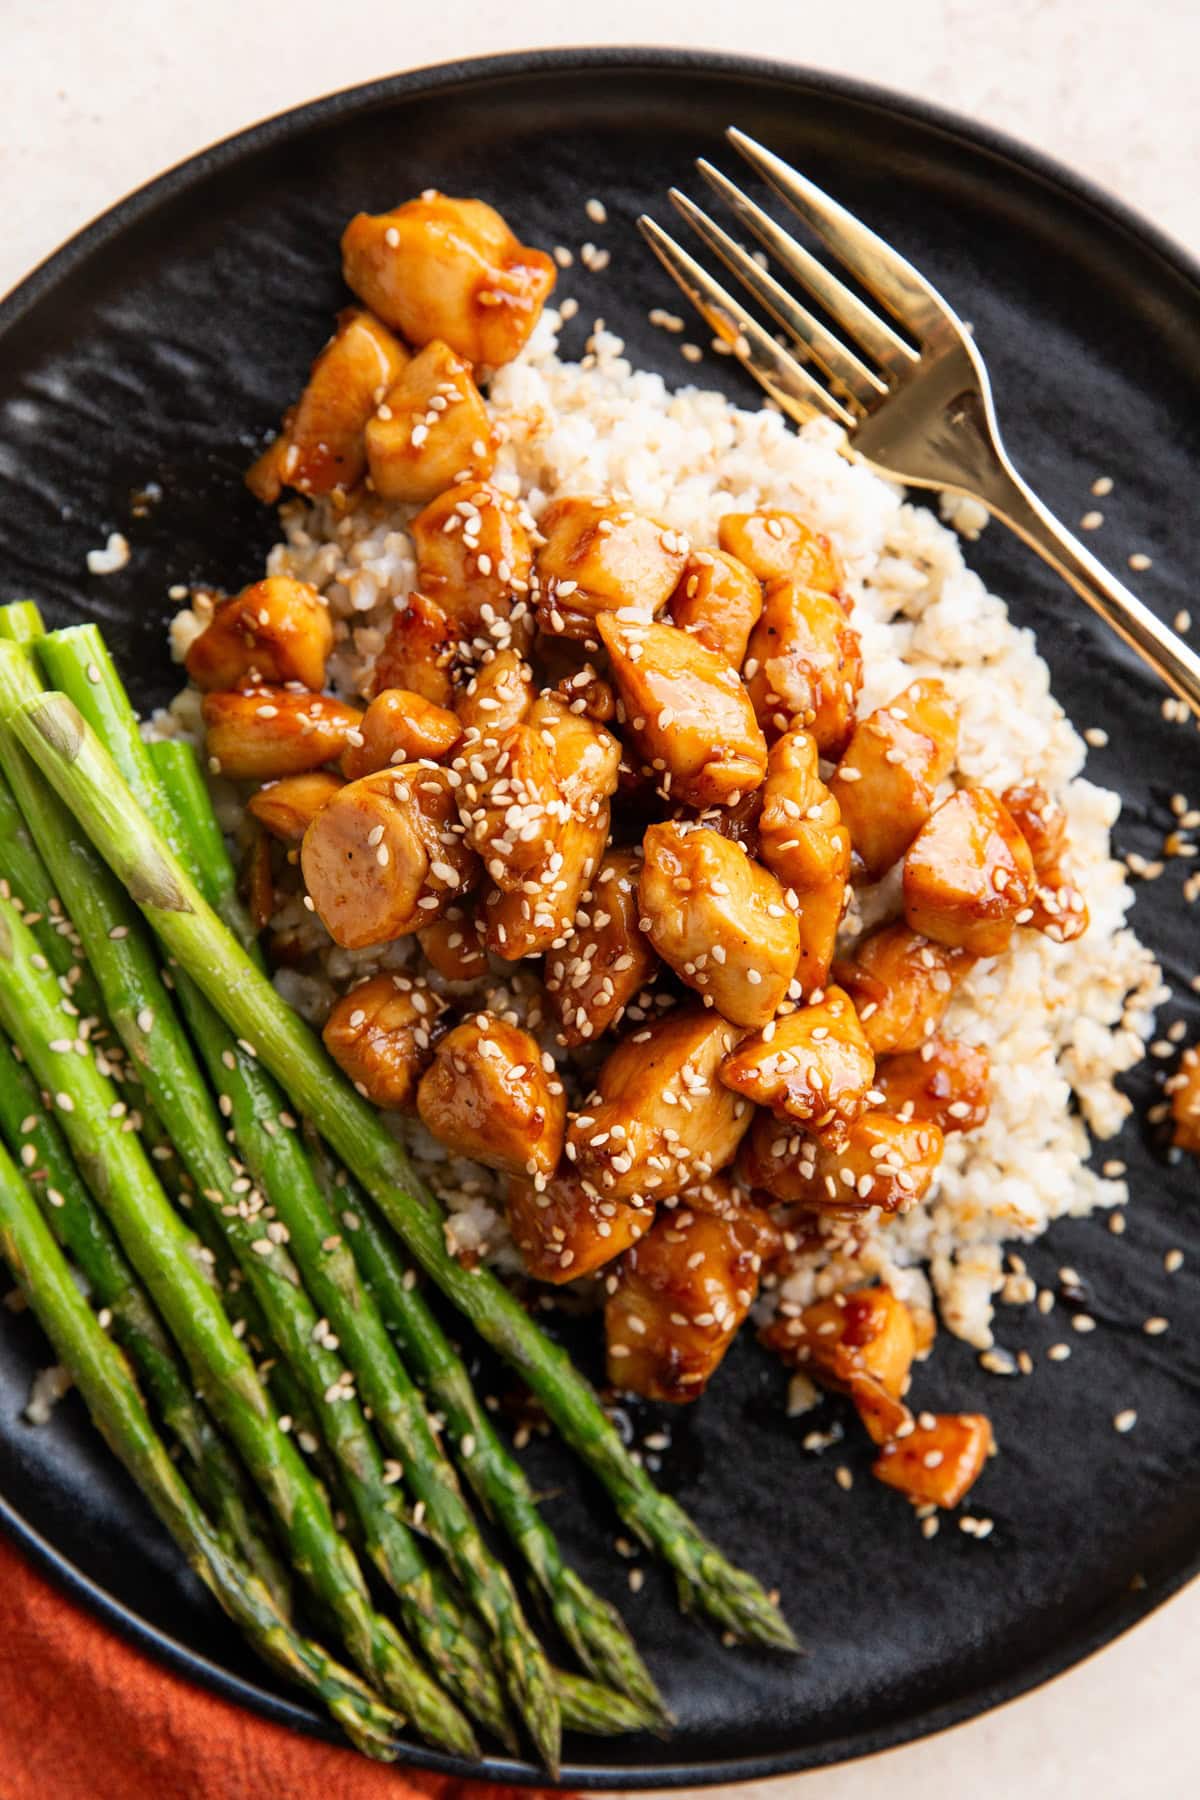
top-left (203, 688), bottom-right (362, 781)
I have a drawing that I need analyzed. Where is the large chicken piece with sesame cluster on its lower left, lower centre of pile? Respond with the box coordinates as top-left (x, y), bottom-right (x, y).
top-left (567, 1006), bottom-right (752, 1201)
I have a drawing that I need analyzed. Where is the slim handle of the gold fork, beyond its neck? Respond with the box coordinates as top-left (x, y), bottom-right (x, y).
top-left (979, 457), bottom-right (1200, 716)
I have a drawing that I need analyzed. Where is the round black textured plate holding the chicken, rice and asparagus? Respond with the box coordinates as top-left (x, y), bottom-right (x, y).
top-left (0, 50), bottom-right (1200, 1787)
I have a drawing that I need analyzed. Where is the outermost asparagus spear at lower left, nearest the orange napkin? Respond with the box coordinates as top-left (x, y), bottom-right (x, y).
top-left (0, 1147), bottom-right (403, 1760)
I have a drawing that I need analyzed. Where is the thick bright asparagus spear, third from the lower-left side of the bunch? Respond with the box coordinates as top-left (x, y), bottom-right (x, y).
top-left (0, 885), bottom-right (473, 1753)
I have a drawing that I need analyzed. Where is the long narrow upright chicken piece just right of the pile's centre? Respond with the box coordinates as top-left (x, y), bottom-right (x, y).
top-left (757, 731), bottom-right (851, 995)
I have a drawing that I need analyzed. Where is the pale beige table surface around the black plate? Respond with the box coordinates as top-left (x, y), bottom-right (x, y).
top-left (0, 0), bottom-right (1200, 1800)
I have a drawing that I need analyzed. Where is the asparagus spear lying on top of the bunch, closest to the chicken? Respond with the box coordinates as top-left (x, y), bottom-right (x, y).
top-left (13, 676), bottom-right (795, 1649)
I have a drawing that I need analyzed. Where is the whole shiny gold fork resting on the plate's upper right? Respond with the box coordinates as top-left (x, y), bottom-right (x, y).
top-left (639, 130), bottom-right (1200, 715)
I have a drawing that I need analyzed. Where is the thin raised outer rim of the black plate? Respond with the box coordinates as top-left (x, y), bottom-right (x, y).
top-left (0, 45), bottom-right (1200, 1791)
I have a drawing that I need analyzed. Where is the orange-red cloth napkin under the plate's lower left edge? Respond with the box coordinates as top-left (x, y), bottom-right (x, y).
top-left (0, 1539), bottom-right (557, 1800)
